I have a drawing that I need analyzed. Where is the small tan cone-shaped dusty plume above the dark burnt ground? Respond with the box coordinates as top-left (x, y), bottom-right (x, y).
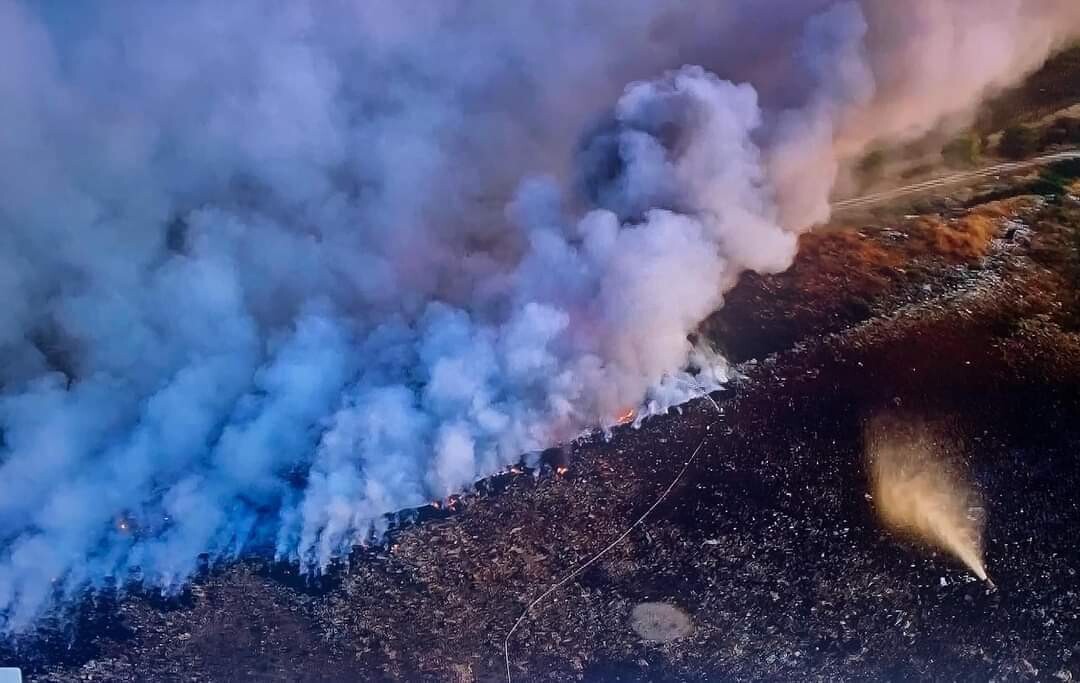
top-left (865, 416), bottom-right (989, 581)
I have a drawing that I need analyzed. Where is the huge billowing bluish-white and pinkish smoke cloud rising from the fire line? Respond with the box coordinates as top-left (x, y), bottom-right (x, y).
top-left (0, 0), bottom-right (1080, 629)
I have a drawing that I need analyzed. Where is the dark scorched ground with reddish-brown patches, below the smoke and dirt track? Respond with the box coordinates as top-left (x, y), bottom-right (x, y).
top-left (0, 155), bottom-right (1080, 681)
